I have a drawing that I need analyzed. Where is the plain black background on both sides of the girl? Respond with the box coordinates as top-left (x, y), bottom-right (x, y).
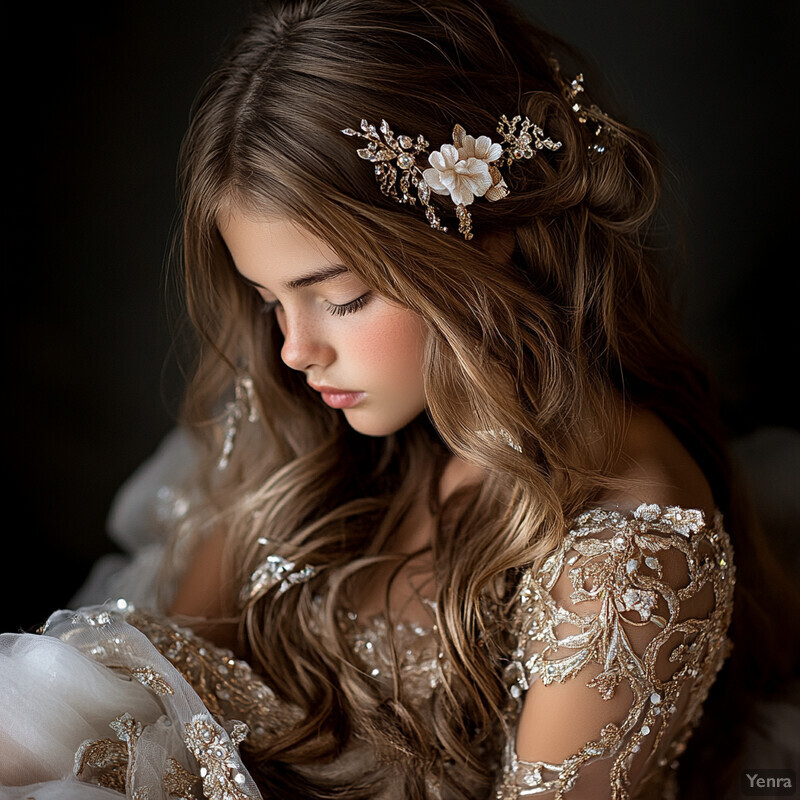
top-left (6, 0), bottom-right (800, 630)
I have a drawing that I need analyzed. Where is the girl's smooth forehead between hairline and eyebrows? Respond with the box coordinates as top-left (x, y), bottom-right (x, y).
top-left (217, 209), bottom-right (340, 283)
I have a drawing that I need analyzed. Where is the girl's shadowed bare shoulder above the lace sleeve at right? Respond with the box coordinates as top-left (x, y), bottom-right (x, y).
top-left (608, 409), bottom-right (715, 514)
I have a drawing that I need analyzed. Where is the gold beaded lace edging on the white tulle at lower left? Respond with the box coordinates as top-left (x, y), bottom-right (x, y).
top-left (36, 600), bottom-right (260, 800)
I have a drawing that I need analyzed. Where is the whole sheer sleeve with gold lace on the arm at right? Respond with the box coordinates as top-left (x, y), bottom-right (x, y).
top-left (497, 505), bottom-right (734, 800)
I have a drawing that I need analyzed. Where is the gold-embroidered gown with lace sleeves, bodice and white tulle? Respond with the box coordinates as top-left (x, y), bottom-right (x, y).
top-left (0, 428), bottom-right (735, 800)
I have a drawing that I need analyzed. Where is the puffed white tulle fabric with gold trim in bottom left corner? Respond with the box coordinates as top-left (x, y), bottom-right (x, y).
top-left (0, 606), bottom-right (261, 800)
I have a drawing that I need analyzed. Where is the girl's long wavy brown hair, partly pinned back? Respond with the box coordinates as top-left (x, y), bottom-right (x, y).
top-left (170, 0), bottom-right (800, 798)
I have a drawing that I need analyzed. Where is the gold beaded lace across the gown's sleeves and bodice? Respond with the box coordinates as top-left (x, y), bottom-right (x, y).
top-left (17, 505), bottom-right (734, 800)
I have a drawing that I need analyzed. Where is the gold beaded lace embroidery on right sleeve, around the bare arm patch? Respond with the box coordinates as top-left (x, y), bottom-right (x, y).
top-left (497, 505), bottom-right (735, 799)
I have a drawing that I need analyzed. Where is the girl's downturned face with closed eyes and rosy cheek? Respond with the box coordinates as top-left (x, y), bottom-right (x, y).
top-left (219, 210), bottom-right (426, 436)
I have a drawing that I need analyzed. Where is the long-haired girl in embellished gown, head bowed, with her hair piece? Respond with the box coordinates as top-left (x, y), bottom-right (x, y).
top-left (0, 0), bottom-right (794, 800)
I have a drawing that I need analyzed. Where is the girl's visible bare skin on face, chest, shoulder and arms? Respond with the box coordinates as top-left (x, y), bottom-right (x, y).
top-left (181, 213), bottom-right (714, 788)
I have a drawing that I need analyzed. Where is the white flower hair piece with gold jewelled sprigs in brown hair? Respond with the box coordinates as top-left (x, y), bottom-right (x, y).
top-left (342, 116), bottom-right (561, 239)
